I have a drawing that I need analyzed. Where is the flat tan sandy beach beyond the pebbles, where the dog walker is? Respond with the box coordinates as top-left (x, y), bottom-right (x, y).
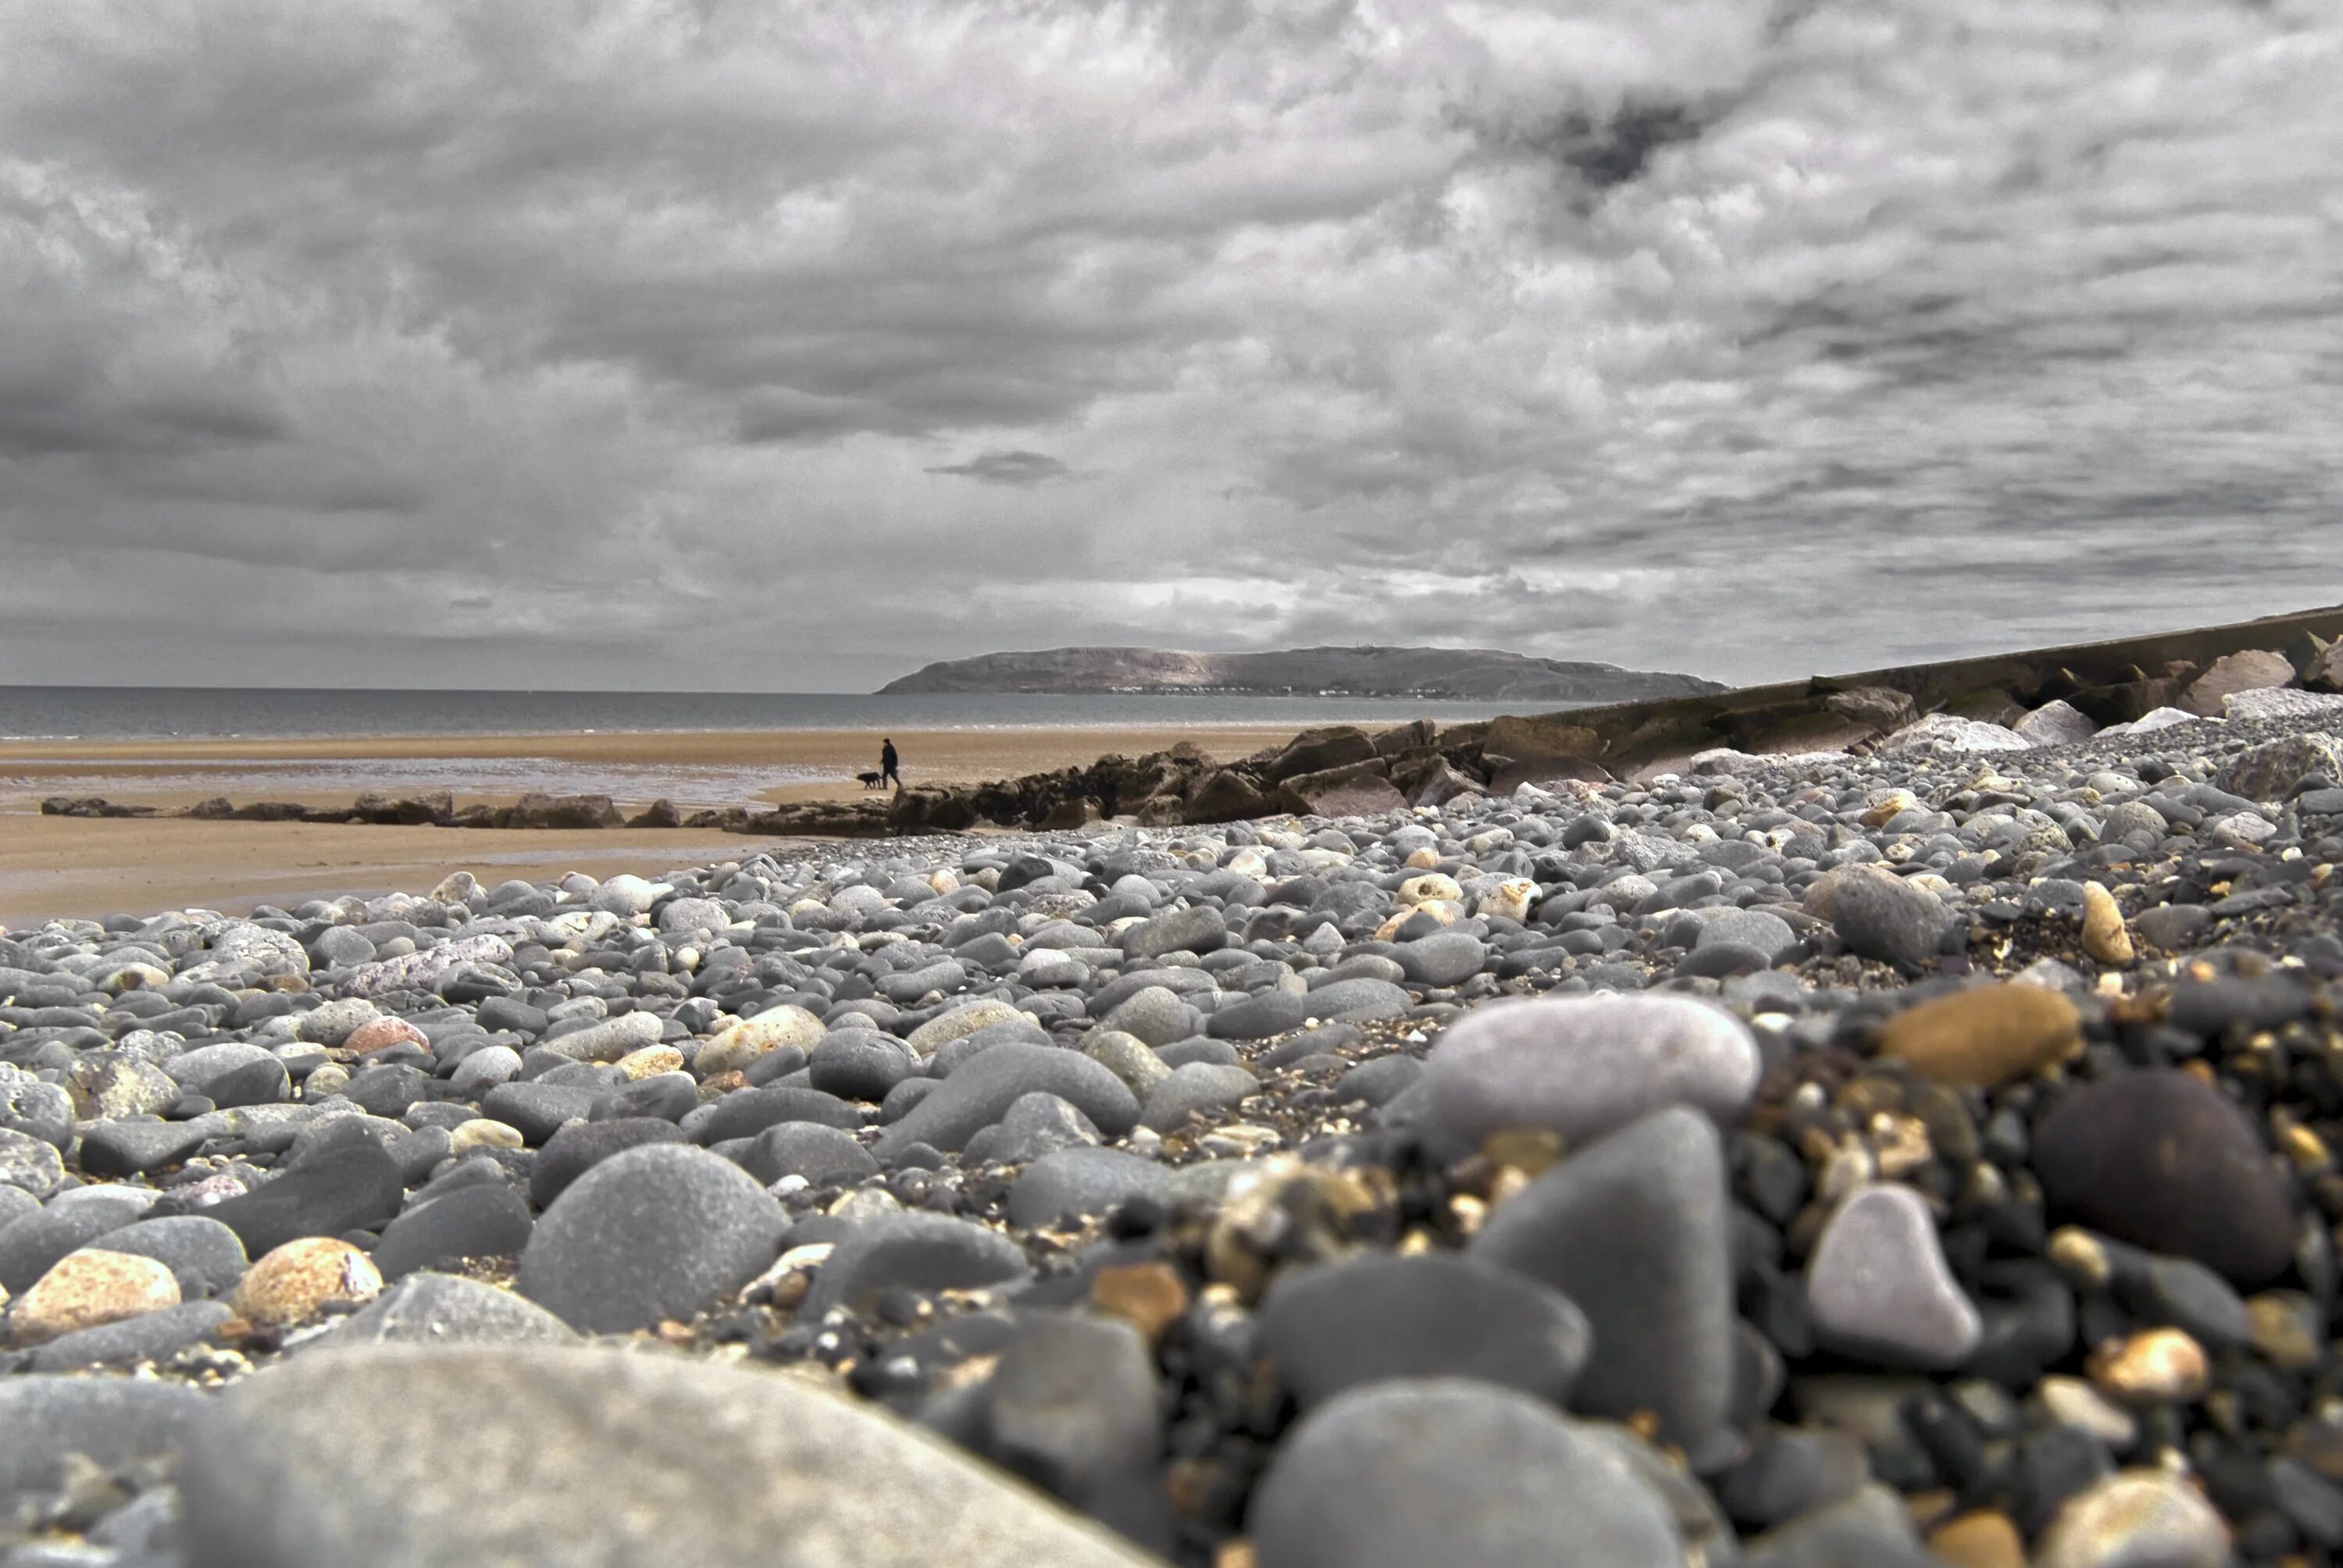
top-left (0, 724), bottom-right (1291, 926)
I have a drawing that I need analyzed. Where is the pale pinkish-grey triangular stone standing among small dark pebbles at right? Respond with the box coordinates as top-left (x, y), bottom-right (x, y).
top-left (1806, 1184), bottom-right (1985, 1371)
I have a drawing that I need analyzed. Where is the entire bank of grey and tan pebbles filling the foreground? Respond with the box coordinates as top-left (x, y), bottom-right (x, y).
top-left (13, 689), bottom-right (2343, 1568)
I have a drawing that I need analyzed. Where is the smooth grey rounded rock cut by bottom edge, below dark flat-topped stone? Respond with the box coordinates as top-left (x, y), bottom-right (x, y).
top-left (1246, 1378), bottom-right (1685, 1568)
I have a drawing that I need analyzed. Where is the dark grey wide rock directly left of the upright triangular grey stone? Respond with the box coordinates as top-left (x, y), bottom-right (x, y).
top-left (1258, 1252), bottom-right (1591, 1411)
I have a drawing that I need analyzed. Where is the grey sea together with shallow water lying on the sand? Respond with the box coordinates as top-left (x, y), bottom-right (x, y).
top-left (0, 686), bottom-right (1560, 814)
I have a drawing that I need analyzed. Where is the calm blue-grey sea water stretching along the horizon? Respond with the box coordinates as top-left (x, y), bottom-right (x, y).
top-left (0, 686), bottom-right (1560, 740)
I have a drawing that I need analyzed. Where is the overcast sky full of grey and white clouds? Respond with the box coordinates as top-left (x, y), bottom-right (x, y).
top-left (0, 0), bottom-right (2343, 689)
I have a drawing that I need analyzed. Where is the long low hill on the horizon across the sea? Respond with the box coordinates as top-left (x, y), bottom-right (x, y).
top-left (879, 647), bottom-right (1724, 703)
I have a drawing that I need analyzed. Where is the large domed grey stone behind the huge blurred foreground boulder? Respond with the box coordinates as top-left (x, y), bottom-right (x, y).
top-left (520, 1144), bottom-right (785, 1334)
